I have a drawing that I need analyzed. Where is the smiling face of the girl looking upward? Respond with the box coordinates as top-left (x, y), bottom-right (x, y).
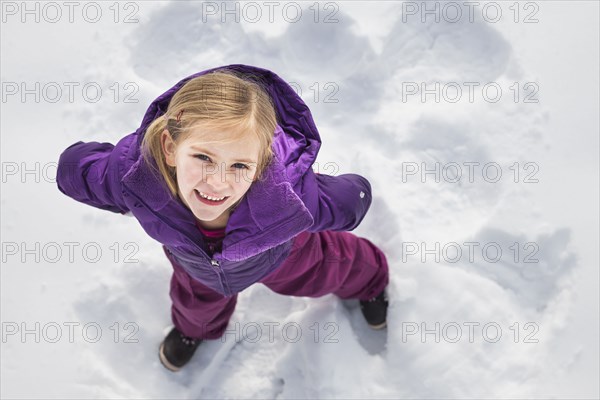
top-left (161, 128), bottom-right (260, 229)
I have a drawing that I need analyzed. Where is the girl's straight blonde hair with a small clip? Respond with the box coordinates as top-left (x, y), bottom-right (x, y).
top-left (142, 69), bottom-right (277, 197)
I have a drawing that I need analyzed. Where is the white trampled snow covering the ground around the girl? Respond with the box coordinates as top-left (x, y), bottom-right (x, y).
top-left (0, 1), bottom-right (600, 399)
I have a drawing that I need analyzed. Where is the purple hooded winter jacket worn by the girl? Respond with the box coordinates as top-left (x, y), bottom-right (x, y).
top-left (56, 64), bottom-right (371, 296)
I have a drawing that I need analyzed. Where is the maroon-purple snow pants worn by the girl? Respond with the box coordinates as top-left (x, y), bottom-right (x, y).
top-left (164, 231), bottom-right (389, 339)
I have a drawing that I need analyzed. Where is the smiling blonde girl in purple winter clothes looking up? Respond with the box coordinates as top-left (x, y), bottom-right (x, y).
top-left (57, 64), bottom-right (389, 371)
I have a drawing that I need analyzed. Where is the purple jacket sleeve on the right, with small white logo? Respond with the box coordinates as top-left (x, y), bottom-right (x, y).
top-left (303, 168), bottom-right (371, 232)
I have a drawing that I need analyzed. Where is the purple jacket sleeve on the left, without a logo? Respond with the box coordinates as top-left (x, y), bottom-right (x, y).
top-left (56, 142), bottom-right (129, 214)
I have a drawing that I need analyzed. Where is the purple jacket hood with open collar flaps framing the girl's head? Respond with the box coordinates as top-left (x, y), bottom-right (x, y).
top-left (123, 64), bottom-right (321, 261)
